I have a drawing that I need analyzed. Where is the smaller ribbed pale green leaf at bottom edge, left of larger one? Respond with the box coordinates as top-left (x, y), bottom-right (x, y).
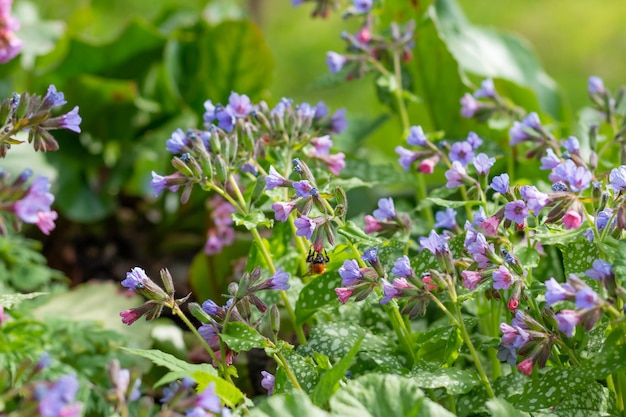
top-left (248, 391), bottom-right (330, 417)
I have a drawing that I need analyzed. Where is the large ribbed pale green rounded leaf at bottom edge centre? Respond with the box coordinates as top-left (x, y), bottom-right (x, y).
top-left (330, 374), bottom-right (454, 417)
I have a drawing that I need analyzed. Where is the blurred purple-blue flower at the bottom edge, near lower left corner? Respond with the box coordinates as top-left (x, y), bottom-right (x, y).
top-left (36, 374), bottom-right (82, 417)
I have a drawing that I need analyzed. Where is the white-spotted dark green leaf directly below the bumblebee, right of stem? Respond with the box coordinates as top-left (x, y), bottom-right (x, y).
top-left (296, 273), bottom-right (341, 324)
